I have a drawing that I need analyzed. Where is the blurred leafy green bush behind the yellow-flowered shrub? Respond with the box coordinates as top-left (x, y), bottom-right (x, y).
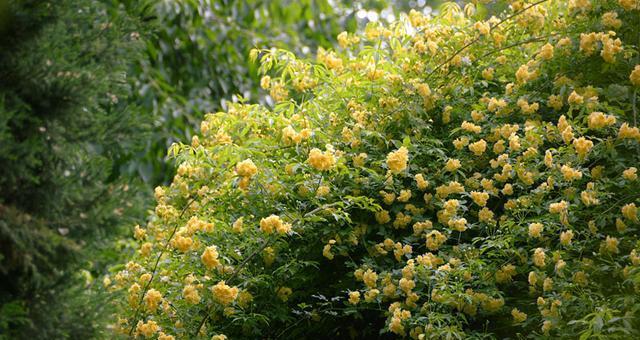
top-left (129, 0), bottom-right (410, 186)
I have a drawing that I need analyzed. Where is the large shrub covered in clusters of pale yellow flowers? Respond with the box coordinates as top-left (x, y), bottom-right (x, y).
top-left (111, 0), bottom-right (640, 339)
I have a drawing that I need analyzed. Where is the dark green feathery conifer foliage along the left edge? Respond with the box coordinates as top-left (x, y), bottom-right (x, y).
top-left (0, 0), bottom-right (149, 338)
